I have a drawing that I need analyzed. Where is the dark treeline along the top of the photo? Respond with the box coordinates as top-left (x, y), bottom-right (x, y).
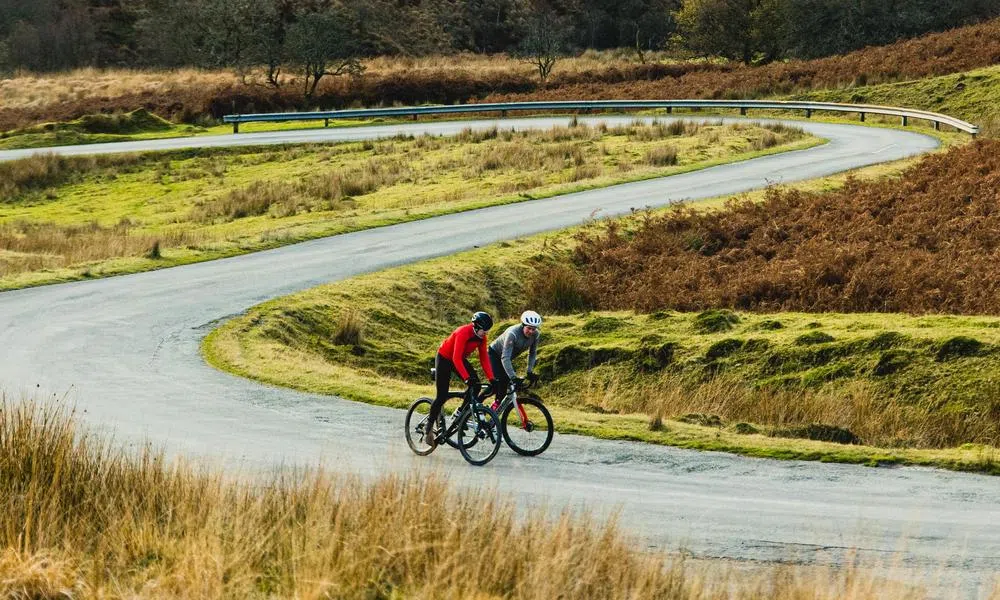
top-left (0, 0), bottom-right (1000, 73)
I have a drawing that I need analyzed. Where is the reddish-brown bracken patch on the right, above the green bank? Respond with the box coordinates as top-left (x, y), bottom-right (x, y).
top-left (556, 141), bottom-right (1000, 314)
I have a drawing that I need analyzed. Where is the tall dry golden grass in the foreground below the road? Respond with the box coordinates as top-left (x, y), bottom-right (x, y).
top-left (0, 397), bottom-right (952, 600)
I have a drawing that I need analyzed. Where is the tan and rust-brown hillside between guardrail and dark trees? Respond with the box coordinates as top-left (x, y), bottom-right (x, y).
top-left (0, 19), bottom-right (1000, 130)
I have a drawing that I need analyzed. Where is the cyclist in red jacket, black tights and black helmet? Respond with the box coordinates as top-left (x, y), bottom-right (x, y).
top-left (424, 311), bottom-right (496, 446)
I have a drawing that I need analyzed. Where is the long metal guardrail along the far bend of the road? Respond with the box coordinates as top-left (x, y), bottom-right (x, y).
top-left (222, 100), bottom-right (979, 137)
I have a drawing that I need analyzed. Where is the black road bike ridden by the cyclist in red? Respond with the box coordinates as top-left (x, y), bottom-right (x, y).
top-left (406, 369), bottom-right (502, 467)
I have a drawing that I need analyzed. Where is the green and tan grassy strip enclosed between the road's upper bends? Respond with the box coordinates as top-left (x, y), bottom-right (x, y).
top-left (0, 123), bottom-right (822, 289)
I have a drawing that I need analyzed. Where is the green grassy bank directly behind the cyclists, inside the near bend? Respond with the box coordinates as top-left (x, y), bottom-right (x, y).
top-left (203, 219), bottom-right (1000, 474)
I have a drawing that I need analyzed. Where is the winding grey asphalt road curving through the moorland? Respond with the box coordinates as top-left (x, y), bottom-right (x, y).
top-left (0, 117), bottom-right (1000, 598)
